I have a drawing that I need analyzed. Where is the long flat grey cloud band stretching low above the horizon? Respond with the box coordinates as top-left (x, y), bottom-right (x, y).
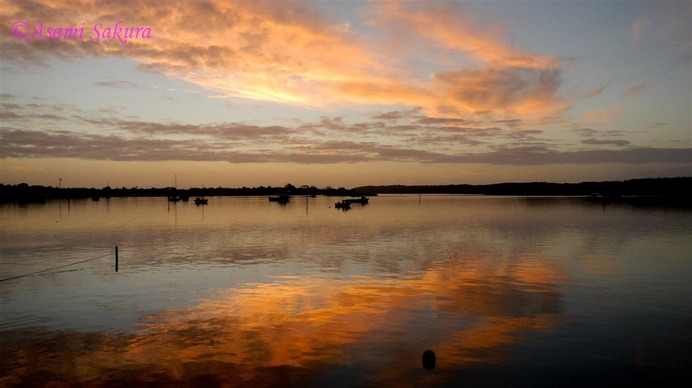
top-left (0, 124), bottom-right (692, 165)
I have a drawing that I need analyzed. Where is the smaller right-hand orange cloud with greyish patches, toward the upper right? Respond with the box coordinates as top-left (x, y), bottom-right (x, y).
top-left (372, 1), bottom-right (570, 116)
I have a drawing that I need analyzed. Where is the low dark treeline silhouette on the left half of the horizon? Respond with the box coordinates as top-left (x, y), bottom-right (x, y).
top-left (0, 183), bottom-right (368, 203)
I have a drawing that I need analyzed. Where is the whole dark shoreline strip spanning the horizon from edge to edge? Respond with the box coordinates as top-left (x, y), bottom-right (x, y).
top-left (0, 177), bottom-right (692, 203)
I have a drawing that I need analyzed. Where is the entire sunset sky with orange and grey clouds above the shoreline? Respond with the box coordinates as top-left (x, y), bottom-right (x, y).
top-left (0, 0), bottom-right (692, 188)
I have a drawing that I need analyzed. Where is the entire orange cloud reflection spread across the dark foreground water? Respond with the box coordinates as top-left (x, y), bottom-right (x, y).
top-left (0, 252), bottom-right (563, 385)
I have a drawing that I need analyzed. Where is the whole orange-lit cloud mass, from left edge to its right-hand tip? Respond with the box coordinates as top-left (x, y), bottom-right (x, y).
top-left (0, 0), bottom-right (569, 117)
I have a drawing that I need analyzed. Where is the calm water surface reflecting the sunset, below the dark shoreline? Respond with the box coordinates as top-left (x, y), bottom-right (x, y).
top-left (0, 196), bottom-right (692, 387)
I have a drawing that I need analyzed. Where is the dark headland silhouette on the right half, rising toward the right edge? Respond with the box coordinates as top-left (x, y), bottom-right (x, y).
top-left (354, 177), bottom-right (692, 197)
